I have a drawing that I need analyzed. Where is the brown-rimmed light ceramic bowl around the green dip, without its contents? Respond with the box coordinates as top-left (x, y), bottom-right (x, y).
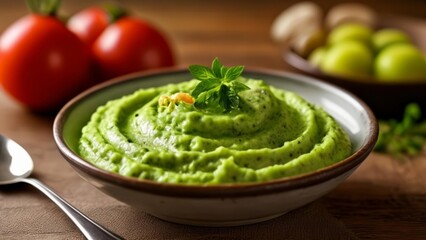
top-left (53, 69), bottom-right (378, 226)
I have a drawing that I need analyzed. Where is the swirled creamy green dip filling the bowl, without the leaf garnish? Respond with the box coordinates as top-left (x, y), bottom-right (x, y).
top-left (79, 77), bottom-right (351, 184)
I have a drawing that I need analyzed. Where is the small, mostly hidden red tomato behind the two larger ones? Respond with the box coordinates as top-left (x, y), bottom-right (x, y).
top-left (67, 7), bottom-right (109, 47)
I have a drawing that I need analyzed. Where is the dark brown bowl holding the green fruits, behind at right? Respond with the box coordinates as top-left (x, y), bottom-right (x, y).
top-left (283, 15), bottom-right (426, 119)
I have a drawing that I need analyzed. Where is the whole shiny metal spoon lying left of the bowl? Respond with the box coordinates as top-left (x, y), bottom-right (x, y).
top-left (0, 135), bottom-right (122, 239)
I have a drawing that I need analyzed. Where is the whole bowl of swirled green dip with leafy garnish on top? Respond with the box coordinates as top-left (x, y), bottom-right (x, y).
top-left (53, 59), bottom-right (378, 226)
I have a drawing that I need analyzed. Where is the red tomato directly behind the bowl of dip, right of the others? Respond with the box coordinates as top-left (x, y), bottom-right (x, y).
top-left (92, 17), bottom-right (174, 80)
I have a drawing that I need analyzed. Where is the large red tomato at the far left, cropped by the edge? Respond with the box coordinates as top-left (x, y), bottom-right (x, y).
top-left (0, 14), bottom-right (90, 111)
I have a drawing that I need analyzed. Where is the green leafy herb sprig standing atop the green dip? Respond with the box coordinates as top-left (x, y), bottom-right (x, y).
top-left (188, 58), bottom-right (250, 112)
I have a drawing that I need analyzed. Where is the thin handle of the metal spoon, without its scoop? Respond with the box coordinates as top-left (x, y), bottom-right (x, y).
top-left (22, 178), bottom-right (122, 240)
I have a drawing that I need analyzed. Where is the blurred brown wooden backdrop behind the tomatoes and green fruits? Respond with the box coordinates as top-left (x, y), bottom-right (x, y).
top-left (0, 0), bottom-right (426, 69)
